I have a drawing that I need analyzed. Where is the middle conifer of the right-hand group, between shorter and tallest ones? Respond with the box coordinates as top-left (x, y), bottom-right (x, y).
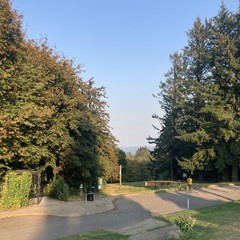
top-left (176, 18), bottom-right (212, 173)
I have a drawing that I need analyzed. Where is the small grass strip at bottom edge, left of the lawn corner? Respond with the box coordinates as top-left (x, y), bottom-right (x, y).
top-left (59, 230), bottom-right (128, 240)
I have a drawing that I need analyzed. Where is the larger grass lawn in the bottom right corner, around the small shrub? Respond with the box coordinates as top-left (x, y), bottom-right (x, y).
top-left (159, 201), bottom-right (240, 240)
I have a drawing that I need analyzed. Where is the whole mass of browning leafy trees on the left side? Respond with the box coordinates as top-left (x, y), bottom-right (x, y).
top-left (0, 0), bottom-right (118, 188)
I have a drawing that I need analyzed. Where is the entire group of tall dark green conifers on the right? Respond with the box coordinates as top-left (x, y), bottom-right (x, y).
top-left (149, 3), bottom-right (240, 181)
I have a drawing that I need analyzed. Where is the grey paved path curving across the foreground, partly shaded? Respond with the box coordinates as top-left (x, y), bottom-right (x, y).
top-left (0, 186), bottom-right (240, 240)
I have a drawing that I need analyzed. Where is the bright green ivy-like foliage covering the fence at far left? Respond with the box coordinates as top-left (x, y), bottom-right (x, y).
top-left (1, 171), bottom-right (32, 208)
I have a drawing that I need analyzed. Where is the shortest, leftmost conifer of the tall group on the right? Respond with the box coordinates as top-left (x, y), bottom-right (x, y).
top-left (149, 53), bottom-right (188, 180)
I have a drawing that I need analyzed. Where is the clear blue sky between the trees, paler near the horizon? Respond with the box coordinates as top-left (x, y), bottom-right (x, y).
top-left (12, 0), bottom-right (239, 148)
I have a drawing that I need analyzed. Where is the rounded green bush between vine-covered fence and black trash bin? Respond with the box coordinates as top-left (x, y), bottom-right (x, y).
top-left (44, 176), bottom-right (69, 201)
